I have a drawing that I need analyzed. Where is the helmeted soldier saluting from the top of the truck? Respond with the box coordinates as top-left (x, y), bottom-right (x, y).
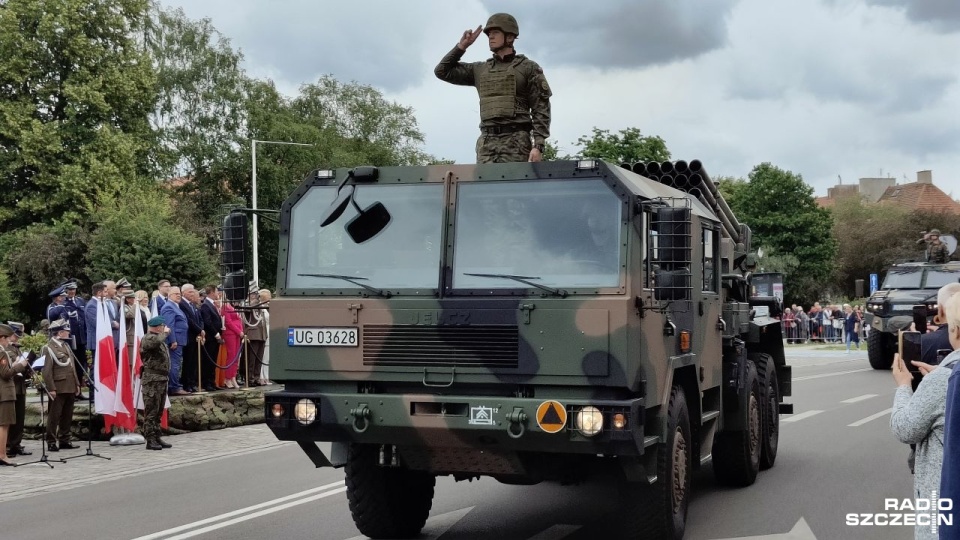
top-left (433, 13), bottom-right (552, 163)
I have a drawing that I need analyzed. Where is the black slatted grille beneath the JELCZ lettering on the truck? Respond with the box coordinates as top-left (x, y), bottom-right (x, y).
top-left (363, 324), bottom-right (520, 368)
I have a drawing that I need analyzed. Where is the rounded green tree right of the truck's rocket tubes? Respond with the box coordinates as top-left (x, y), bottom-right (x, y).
top-left (725, 163), bottom-right (837, 304)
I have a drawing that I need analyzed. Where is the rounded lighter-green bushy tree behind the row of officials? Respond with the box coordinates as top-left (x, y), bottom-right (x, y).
top-left (89, 187), bottom-right (216, 287)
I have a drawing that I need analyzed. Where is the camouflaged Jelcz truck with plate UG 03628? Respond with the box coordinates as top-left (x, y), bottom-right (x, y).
top-left (224, 160), bottom-right (792, 538)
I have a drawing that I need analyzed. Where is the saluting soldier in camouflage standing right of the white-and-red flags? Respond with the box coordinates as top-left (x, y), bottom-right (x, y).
top-left (140, 316), bottom-right (173, 450)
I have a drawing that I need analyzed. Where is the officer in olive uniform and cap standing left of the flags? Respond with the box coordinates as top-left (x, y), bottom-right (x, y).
top-left (42, 319), bottom-right (80, 452)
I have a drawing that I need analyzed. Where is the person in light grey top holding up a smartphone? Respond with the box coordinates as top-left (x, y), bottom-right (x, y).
top-left (890, 302), bottom-right (960, 539)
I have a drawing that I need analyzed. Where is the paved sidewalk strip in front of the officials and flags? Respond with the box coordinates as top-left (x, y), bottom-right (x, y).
top-left (0, 424), bottom-right (294, 502)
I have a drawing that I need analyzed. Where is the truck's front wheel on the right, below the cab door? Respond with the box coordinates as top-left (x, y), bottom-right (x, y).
top-left (620, 386), bottom-right (693, 539)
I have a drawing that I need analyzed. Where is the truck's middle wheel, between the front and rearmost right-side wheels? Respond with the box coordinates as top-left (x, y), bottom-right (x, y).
top-left (713, 361), bottom-right (763, 486)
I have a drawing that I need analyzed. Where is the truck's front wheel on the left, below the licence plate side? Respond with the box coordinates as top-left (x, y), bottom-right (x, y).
top-left (346, 444), bottom-right (436, 538)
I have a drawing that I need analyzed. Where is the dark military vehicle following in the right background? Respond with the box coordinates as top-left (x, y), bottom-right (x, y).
top-left (864, 261), bottom-right (960, 369)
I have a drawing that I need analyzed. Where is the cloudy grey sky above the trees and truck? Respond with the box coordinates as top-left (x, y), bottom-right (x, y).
top-left (162, 0), bottom-right (960, 194)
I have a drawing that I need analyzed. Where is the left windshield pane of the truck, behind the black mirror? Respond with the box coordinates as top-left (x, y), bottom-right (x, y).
top-left (287, 184), bottom-right (443, 289)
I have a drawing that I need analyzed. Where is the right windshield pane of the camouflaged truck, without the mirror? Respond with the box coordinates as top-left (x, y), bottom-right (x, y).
top-left (452, 179), bottom-right (622, 289)
